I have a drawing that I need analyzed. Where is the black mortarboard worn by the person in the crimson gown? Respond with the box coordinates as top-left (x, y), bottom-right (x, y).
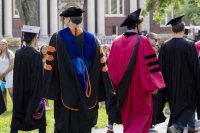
top-left (120, 8), bottom-right (144, 27)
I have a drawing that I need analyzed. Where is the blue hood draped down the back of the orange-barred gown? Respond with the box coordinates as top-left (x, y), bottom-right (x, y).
top-left (58, 28), bottom-right (96, 96)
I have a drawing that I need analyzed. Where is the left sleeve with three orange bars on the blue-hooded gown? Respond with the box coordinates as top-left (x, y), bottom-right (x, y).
top-left (44, 33), bottom-right (60, 100)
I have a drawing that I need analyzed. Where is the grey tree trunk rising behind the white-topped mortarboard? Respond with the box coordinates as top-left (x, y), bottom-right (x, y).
top-left (16, 0), bottom-right (39, 26)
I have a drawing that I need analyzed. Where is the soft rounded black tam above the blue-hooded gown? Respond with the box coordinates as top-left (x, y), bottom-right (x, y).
top-left (60, 7), bottom-right (84, 17)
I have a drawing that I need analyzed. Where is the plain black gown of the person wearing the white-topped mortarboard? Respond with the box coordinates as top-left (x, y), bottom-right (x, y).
top-left (11, 46), bottom-right (46, 131)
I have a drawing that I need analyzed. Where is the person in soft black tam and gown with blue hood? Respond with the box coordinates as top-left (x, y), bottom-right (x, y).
top-left (44, 7), bottom-right (113, 133)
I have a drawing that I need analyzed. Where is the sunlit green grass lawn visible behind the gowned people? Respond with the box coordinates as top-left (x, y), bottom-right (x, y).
top-left (0, 93), bottom-right (108, 133)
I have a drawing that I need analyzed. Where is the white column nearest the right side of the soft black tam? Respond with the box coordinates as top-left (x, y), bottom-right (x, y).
top-left (87, 0), bottom-right (95, 34)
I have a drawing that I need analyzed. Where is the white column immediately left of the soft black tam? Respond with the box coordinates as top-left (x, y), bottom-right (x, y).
top-left (50, 0), bottom-right (58, 35)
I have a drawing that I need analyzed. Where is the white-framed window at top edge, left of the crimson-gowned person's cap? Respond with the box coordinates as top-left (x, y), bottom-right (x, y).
top-left (105, 0), bottom-right (124, 16)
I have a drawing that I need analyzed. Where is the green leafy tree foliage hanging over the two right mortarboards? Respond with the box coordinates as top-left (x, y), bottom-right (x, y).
top-left (143, 0), bottom-right (200, 25)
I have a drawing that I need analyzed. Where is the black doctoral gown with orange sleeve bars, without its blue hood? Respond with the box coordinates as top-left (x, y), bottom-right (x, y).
top-left (45, 29), bottom-right (113, 133)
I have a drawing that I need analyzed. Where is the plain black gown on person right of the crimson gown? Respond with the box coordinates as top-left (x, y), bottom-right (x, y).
top-left (159, 38), bottom-right (199, 126)
